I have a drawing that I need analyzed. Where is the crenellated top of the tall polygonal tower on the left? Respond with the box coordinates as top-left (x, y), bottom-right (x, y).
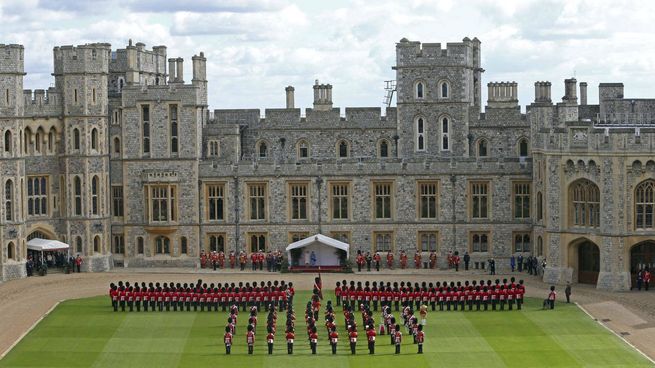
top-left (53, 43), bottom-right (111, 76)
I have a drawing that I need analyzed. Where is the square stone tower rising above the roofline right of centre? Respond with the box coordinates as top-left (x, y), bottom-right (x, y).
top-left (393, 37), bottom-right (483, 158)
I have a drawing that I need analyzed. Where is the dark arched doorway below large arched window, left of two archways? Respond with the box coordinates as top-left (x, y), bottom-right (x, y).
top-left (569, 238), bottom-right (600, 285)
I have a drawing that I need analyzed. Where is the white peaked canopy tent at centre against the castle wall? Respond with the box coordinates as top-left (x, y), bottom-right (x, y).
top-left (286, 234), bottom-right (350, 266)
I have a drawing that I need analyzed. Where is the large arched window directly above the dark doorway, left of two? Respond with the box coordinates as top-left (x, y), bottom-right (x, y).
top-left (569, 179), bottom-right (600, 227)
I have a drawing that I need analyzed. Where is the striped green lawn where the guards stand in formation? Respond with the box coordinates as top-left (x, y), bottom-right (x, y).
top-left (0, 292), bottom-right (652, 368)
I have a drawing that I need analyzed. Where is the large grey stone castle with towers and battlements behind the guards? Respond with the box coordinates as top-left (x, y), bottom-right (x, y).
top-left (0, 38), bottom-right (655, 290)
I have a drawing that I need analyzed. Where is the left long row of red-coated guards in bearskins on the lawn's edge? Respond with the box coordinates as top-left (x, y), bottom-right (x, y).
top-left (109, 280), bottom-right (295, 312)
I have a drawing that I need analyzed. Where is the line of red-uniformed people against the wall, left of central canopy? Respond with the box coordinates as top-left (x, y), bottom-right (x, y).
top-left (200, 249), bottom-right (283, 272)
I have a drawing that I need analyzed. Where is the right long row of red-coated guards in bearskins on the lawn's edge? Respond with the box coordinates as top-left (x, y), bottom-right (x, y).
top-left (334, 277), bottom-right (525, 311)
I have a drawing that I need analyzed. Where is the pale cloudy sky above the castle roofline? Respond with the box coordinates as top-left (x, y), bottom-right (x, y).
top-left (0, 0), bottom-right (655, 109)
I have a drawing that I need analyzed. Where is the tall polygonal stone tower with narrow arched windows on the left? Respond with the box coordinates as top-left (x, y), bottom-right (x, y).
top-left (54, 43), bottom-right (112, 271)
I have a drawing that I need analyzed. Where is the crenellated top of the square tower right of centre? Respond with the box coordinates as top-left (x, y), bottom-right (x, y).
top-left (396, 37), bottom-right (480, 68)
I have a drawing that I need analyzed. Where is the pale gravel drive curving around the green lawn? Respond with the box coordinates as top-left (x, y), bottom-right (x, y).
top-left (0, 268), bottom-right (655, 358)
